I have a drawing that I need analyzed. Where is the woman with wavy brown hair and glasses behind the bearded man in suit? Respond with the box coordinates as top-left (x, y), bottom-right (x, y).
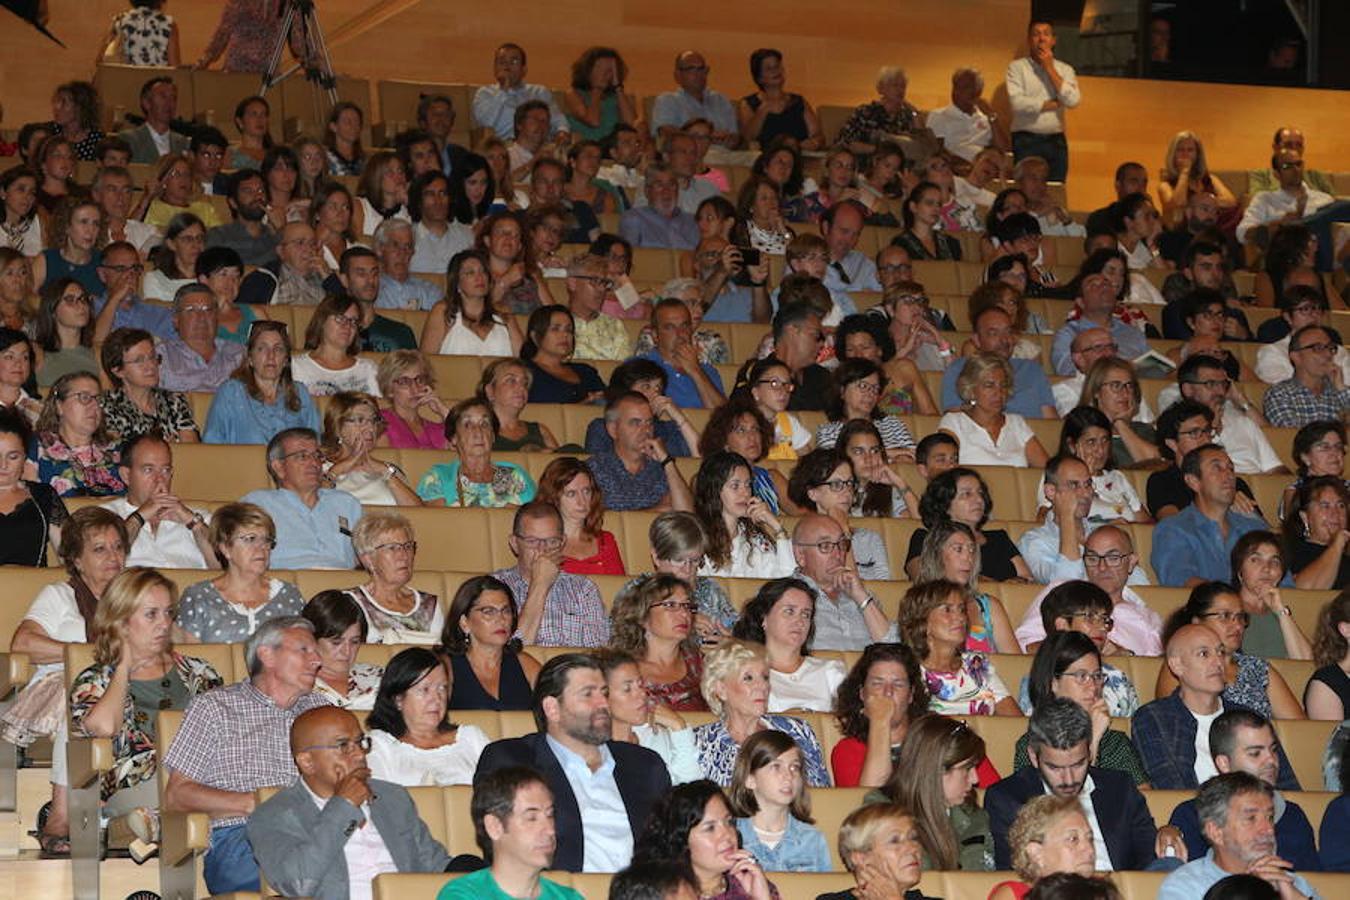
top-left (609, 573), bottom-right (707, 712)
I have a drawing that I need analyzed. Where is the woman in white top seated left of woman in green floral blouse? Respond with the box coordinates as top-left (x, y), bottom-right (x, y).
top-left (321, 391), bottom-right (421, 506)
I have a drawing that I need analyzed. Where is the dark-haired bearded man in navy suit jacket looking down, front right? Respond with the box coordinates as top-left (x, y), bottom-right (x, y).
top-left (984, 698), bottom-right (1185, 872)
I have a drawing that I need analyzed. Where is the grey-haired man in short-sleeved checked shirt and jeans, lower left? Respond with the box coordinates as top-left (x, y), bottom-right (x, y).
top-left (162, 615), bottom-right (328, 893)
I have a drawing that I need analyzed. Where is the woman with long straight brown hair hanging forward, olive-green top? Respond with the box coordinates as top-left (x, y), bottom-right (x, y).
top-left (868, 712), bottom-right (994, 872)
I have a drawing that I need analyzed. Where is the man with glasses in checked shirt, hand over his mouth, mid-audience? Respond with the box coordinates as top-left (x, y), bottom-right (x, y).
top-left (493, 501), bottom-right (609, 646)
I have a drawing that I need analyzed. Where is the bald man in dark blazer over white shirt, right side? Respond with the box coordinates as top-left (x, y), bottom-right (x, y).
top-left (1130, 623), bottom-right (1299, 791)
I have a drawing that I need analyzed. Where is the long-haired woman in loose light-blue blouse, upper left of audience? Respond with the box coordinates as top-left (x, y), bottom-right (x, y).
top-left (205, 320), bottom-right (320, 444)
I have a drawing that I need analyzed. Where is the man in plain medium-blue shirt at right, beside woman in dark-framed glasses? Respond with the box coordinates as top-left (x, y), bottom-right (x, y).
top-left (1153, 444), bottom-right (1288, 587)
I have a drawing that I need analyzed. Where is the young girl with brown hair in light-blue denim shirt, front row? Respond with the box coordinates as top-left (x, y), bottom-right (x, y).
top-left (728, 730), bottom-right (832, 872)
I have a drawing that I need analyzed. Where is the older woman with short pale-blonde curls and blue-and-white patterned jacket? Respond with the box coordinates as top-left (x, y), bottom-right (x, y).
top-left (694, 640), bottom-right (830, 788)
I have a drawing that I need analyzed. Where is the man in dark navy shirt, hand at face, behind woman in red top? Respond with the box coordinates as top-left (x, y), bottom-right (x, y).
top-left (586, 391), bottom-right (694, 511)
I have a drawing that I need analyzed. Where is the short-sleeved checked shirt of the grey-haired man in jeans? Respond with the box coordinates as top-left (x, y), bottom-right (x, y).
top-left (163, 681), bottom-right (331, 828)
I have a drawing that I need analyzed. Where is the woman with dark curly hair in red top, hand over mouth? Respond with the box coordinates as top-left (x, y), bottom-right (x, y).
top-left (830, 644), bottom-right (929, 788)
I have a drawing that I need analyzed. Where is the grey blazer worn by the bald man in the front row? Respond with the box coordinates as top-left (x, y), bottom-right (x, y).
top-left (248, 779), bottom-right (450, 900)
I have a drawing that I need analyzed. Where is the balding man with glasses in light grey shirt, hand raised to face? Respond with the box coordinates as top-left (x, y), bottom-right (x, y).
top-left (792, 515), bottom-right (900, 650)
